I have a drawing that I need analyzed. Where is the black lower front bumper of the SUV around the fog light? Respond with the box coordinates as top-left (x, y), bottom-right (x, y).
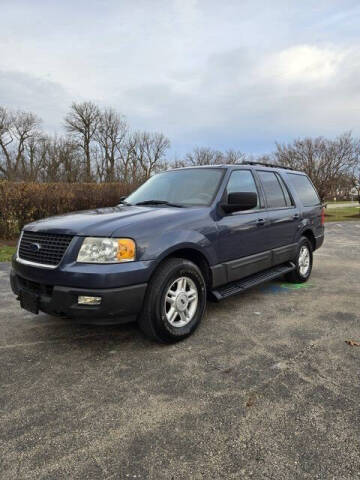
top-left (10, 270), bottom-right (147, 324)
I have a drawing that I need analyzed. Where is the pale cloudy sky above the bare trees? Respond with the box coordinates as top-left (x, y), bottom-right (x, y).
top-left (0, 0), bottom-right (360, 156)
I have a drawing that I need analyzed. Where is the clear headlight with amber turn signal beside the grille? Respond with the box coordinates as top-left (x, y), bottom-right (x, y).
top-left (77, 237), bottom-right (135, 263)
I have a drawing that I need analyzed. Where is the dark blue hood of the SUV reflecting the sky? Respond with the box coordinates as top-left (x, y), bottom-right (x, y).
top-left (25, 205), bottom-right (187, 237)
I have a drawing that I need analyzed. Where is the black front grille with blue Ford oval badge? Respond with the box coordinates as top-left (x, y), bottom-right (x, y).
top-left (19, 231), bottom-right (73, 267)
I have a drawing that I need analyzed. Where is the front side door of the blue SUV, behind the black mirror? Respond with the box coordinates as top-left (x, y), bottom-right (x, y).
top-left (217, 169), bottom-right (271, 282)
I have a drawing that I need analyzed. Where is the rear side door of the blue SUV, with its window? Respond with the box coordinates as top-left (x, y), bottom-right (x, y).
top-left (257, 170), bottom-right (300, 265)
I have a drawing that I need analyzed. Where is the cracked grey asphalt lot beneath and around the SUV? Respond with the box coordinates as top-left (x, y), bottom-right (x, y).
top-left (0, 222), bottom-right (360, 480)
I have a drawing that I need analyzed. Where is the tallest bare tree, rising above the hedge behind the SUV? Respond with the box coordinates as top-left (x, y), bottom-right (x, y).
top-left (65, 102), bottom-right (100, 182)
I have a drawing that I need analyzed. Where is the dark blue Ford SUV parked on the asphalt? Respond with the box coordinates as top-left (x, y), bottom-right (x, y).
top-left (11, 162), bottom-right (324, 342)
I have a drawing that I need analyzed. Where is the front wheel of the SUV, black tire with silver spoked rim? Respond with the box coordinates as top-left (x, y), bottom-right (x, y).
top-left (138, 258), bottom-right (206, 343)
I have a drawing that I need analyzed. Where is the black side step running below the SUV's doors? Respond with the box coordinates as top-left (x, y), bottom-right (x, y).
top-left (211, 262), bottom-right (296, 302)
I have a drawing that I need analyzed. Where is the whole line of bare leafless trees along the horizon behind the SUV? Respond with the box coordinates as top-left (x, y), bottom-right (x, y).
top-left (0, 101), bottom-right (360, 200)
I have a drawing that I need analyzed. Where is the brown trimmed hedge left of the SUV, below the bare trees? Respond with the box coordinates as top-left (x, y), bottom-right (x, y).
top-left (0, 182), bottom-right (135, 239)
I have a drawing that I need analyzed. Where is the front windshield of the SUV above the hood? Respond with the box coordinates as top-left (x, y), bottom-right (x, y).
top-left (126, 168), bottom-right (224, 205)
